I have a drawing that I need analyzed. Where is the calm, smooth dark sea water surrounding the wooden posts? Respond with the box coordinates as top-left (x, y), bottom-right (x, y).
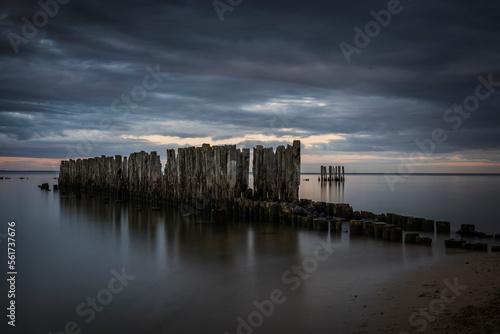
top-left (0, 173), bottom-right (500, 334)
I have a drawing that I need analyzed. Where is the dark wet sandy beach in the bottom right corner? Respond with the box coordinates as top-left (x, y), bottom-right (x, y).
top-left (376, 252), bottom-right (500, 334)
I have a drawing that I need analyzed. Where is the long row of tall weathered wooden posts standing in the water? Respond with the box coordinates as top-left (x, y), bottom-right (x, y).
top-left (59, 141), bottom-right (300, 204)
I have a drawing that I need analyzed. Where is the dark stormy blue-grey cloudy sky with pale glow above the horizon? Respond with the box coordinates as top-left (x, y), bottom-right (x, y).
top-left (0, 0), bottom-right (500, 173)
